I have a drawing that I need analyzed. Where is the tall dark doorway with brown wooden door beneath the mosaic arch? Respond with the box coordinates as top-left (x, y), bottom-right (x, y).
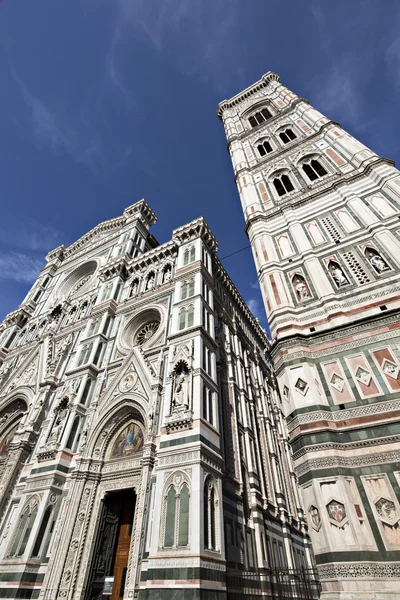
top-left (86, 489), bottom-right (136, 600)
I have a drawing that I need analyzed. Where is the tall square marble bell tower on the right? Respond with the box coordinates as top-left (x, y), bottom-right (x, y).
top-left (218, 72), bottom-right (400, 600)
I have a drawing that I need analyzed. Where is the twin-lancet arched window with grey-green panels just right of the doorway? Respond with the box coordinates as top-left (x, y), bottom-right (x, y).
top-left (163, 475), bottom-right (190, 548)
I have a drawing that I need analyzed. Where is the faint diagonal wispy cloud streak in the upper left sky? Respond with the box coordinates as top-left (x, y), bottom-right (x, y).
top-left (11, 69), bottom-right (103, 168)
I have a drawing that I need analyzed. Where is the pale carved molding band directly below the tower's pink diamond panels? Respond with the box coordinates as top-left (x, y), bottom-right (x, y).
top-left (287, 399), bottom-right (400, 432)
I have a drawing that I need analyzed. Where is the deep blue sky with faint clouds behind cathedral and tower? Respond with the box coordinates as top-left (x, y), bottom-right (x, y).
top-left (0, 0), bottom-right (400, 323)
